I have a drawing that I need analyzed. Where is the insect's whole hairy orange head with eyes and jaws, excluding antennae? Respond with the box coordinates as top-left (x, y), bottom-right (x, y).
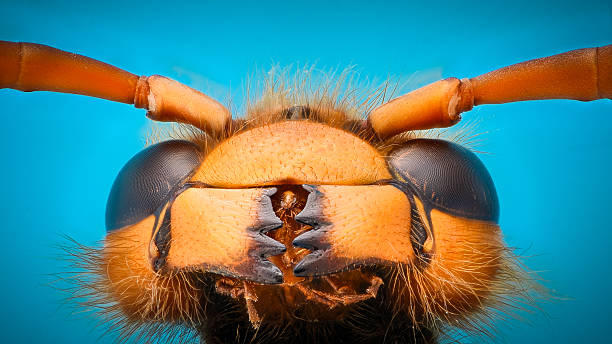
top-left (70, 99), bottom-right (529, 343)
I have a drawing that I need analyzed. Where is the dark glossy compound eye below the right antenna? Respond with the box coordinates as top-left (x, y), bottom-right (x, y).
top-left (389, 139), bottom-right (499, 223)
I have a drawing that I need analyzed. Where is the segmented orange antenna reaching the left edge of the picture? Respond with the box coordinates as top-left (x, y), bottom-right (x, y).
top-left (0, 41), bottom-right (231, 134)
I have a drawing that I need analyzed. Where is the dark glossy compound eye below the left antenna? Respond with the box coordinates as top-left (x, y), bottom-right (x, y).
top-left (106, 140), bottom-right (201, 231)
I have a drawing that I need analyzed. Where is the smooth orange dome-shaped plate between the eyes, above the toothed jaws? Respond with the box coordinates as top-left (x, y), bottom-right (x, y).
top-left (192, 121), bottom-right (391, 188)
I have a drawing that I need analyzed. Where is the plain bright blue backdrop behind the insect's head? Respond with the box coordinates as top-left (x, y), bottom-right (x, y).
top-left (0, 1), bottom-right (612, 343)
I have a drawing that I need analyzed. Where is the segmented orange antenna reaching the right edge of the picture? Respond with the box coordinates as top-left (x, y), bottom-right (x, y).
top-left (368, 45), bottom-right (612, 137)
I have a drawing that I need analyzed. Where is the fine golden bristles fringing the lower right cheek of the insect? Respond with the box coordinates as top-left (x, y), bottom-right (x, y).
top-left (391, 234), bottom-right (547, 342)
